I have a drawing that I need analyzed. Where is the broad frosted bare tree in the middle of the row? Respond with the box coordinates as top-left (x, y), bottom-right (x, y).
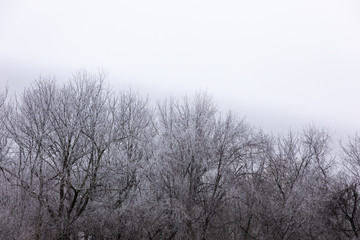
top-left (148, 94), bottom-right (253, 239)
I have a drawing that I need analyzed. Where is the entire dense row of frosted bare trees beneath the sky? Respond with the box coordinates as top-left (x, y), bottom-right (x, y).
top-left (0, 73), bottom-right (360, 240)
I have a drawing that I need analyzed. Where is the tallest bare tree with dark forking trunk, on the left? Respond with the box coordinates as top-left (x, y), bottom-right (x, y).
top-left (2, 73), bottom-right (145, 239)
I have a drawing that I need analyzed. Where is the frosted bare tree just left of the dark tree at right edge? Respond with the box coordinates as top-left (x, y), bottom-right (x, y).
top-left (255, 128), bottom-right (332, 239)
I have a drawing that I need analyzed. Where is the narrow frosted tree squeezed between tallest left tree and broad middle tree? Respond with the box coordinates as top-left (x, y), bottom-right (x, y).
top-left (84, 90), bottom-right (155, 239)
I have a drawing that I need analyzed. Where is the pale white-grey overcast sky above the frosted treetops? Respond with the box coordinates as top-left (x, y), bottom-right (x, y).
top-left (0, 0), bottom-right (360, 135)
